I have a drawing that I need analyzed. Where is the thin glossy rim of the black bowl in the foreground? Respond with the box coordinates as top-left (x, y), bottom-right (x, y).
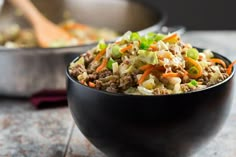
top-left (66, 47), bottom-right (235, 97)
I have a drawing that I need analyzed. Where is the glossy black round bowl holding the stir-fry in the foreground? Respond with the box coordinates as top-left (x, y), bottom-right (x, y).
top-left (67, 50), bottom-right (235, 157)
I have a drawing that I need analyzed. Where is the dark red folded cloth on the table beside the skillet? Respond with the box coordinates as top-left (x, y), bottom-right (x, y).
top-left (30, 90), bottom-right (67, 108)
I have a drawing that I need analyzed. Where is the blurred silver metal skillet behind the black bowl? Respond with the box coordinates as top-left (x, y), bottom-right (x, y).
top-left (0, 0), bottom-right (166, 97)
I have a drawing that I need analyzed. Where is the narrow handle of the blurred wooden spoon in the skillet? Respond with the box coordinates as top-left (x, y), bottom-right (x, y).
top-left (8, 0), bottom-right (47, 26)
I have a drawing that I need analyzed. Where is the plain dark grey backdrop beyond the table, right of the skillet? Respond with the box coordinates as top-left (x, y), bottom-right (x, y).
top-left (138, 0), bottom-right (236, 30)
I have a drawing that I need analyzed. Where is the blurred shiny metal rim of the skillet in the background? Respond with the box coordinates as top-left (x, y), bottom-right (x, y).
top-left (0, 0), bottom-right (168, 53)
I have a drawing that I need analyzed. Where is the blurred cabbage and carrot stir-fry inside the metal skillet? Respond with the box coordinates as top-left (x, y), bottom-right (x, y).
top-left (0, 20), bottom-right (118, 48)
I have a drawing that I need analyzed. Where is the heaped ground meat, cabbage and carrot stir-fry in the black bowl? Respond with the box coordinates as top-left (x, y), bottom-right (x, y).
top-left (69, 32), bottom-right (236, 95)
